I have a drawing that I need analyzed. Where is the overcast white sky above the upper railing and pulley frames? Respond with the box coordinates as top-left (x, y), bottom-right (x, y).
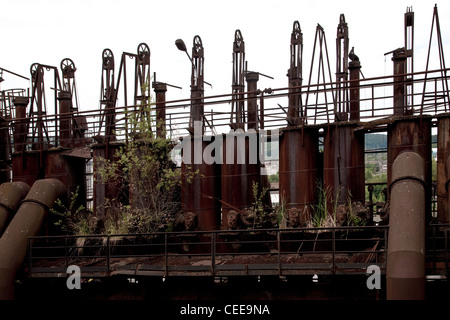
top-left (0, 0), bottom-right (450, 111)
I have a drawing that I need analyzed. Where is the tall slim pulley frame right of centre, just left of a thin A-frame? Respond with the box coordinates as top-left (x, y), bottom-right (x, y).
top-left (287, 21), bottom-right (305, 126)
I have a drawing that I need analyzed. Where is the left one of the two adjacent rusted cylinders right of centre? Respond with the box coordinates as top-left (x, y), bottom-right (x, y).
top-left (279, 126), bottom-right (319, 212)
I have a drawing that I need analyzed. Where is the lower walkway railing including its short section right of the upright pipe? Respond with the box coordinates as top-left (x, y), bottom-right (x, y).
top-left (28, 224), bottom-right (450, 277)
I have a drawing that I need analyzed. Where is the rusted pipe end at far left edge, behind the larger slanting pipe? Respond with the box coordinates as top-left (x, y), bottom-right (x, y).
top-left (0, 182), bottom-right (30, 236)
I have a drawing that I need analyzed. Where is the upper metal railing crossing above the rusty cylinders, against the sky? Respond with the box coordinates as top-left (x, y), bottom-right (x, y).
top-left (2, 69), bottom-right (450, 150)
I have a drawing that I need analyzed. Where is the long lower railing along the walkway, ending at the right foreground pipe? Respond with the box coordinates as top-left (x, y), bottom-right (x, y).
top-left (27, 226), bottom-right (388, 277)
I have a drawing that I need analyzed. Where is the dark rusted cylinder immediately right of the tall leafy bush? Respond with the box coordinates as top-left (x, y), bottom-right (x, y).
top-left (181, 137), bottom-right (220, 231)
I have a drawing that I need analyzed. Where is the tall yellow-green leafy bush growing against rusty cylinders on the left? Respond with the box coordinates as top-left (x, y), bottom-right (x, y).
top-left (96, 80), bottom-right (197, 234)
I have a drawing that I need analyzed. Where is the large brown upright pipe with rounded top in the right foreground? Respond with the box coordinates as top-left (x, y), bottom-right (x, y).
top-left (386, 152), bottom-right (426, 300)
